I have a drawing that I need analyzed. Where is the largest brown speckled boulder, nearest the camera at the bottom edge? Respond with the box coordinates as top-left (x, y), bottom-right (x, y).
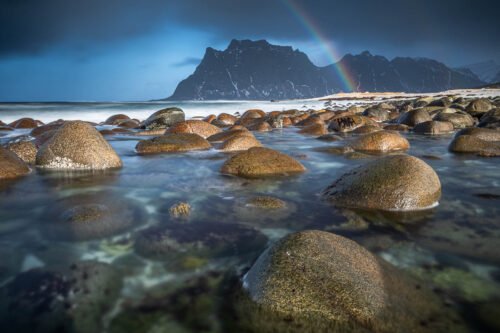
top-left (237, 231), bottom-right (465, 333)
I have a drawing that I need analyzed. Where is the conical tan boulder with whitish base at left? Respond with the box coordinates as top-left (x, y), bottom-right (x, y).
top-left (36, 121), bottom-right (122, 169)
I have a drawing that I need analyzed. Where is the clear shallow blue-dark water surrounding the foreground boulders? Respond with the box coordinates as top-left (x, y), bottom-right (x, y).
top-left (0, 129), bottom-right (500, 332)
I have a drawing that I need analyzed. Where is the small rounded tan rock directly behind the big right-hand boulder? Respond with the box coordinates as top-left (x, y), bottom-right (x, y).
top-left (349, 131), bottom-right (410, 152)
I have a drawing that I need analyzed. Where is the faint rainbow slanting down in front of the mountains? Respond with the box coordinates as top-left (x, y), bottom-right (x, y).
top-left (282, 0), bottom-right (356, 92)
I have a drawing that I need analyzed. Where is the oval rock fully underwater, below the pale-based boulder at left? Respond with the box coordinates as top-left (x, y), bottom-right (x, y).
top-left (41, 192), bottom-right (145, 241)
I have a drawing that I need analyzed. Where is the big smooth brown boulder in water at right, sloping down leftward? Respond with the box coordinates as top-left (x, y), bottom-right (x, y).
top-left (323, 155), bottom-right (441, 210)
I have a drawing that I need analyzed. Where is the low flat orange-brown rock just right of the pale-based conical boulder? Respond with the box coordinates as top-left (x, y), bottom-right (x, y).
top-left (135, 133), bottom-right (212, 154)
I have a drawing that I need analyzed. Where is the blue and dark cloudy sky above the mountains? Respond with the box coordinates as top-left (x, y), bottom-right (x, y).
top-left (0, 0), bottom-right (500, 101)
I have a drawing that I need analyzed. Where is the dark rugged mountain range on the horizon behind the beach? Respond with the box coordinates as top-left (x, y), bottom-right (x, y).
top-left (168, 40), bottom-right (486, 100)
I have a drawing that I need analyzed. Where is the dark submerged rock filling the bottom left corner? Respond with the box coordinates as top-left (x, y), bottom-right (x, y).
top-left (0, 261), bottom-right (122, 333)
